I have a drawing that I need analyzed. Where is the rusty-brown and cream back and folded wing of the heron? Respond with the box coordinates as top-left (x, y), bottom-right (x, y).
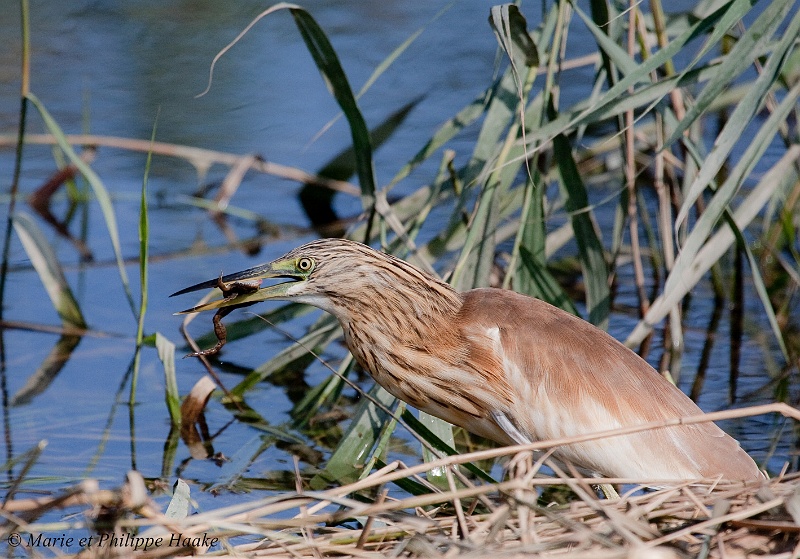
top-left (457, 289), bottom-right (762, 480)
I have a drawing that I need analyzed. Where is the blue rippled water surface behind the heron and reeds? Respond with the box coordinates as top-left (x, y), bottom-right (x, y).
top-left (0, 0), bottom-right (785, 544)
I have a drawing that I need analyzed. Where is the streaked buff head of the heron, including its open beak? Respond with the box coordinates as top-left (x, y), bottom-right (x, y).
top-left (173, 239), bottom-right (457, 319)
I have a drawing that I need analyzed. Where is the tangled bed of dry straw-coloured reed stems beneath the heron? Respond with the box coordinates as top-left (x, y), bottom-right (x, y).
top-left (2, 440), bottom-right (800, 559)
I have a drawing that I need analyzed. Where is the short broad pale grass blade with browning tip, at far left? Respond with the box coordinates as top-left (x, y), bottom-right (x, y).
top-left (14, 212), bottom-right (86, 329)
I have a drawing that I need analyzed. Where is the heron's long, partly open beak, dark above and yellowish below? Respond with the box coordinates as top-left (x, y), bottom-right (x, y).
top-left (170, 260), bottom-right (306, 314)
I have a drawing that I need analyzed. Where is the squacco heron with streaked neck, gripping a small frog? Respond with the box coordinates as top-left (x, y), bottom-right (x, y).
top-left (175, 239), bottom-right (763, 481)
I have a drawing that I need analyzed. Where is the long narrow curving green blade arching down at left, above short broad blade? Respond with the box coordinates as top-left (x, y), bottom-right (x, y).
top-left (27, 93), bottom-right (139, 319)
